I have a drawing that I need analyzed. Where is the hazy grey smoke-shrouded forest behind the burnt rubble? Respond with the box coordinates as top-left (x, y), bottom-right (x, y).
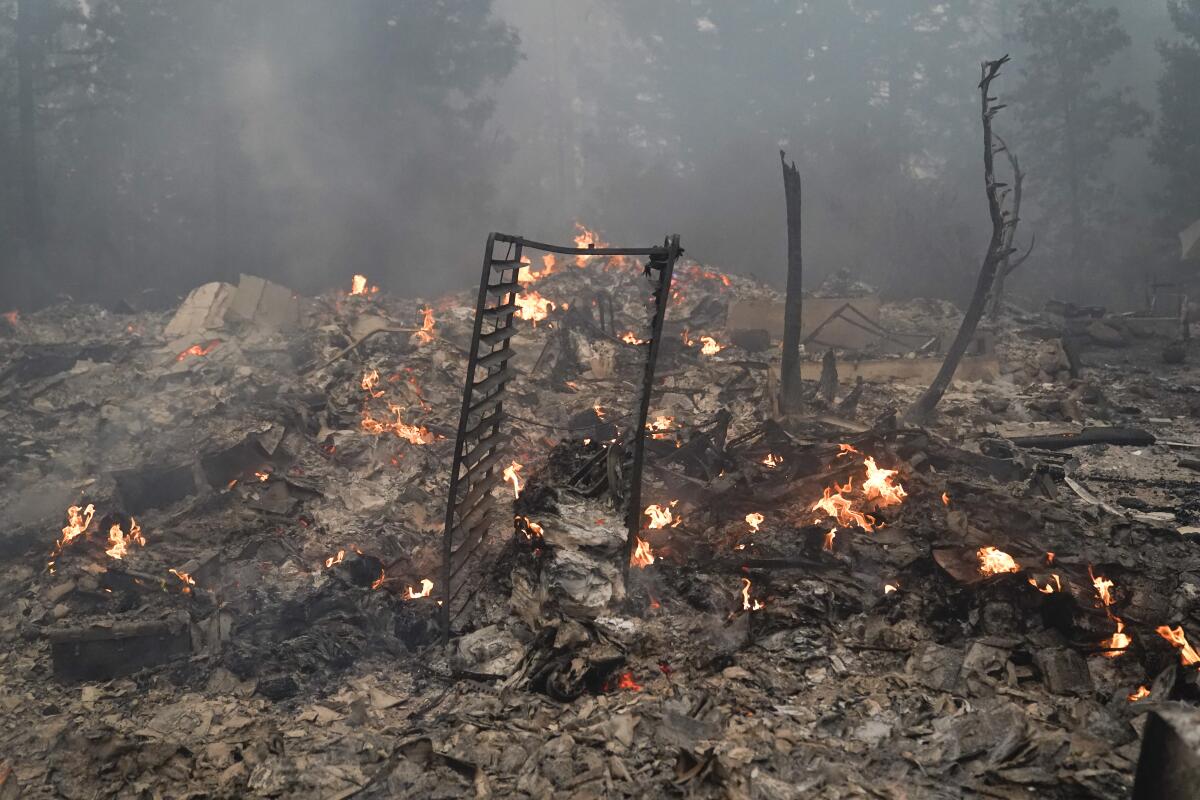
top-left (0, 0), bottom-right (1200, 308)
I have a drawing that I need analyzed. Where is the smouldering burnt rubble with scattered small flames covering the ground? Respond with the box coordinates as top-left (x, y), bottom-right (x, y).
top-left (0, 247), bottom-right (1200, 799)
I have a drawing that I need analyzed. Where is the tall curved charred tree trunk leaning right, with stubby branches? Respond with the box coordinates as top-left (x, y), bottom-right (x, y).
top-left (905, 55), bottom-right (1008, 423)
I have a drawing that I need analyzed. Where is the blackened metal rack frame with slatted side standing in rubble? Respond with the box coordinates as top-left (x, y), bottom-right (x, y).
top-left (440, 233), bottom-right (683, 642)
